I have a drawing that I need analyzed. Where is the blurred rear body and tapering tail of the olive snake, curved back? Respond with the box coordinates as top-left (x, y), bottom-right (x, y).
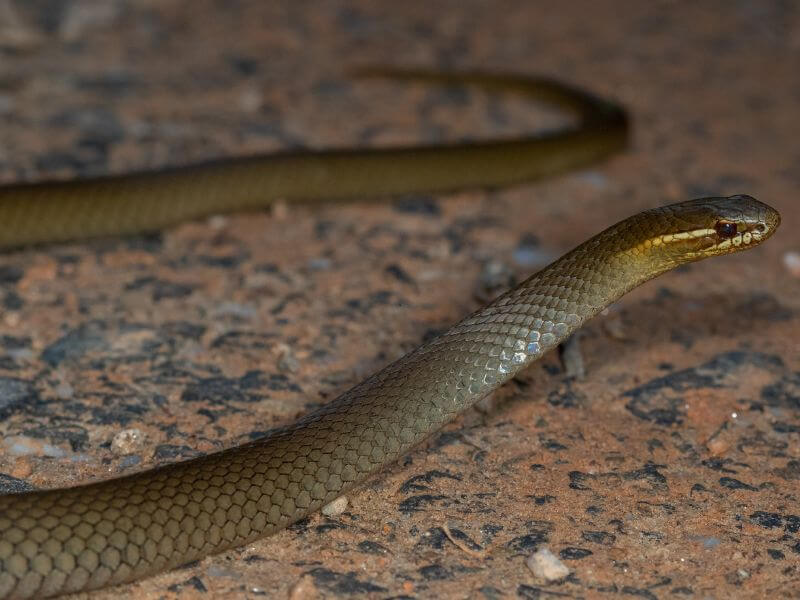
top-left (0, 69), bottom-right (628, 248)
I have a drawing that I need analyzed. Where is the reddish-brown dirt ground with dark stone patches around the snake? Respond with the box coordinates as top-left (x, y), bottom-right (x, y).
top-left (0, 0), bottom-right (800, 600)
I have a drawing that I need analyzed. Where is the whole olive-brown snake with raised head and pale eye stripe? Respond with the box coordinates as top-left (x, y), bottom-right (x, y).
top-left (0, 71), bottom-right (780, 599)
